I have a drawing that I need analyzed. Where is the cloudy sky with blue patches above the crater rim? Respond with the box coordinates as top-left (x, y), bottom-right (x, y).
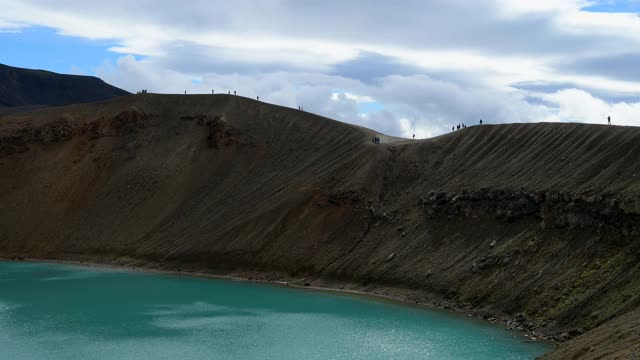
top-left (0, 0), bottom-right (640, 137)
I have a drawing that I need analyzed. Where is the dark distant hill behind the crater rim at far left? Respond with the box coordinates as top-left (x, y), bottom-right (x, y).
top-left (0, 64), bottom-right (129, 110)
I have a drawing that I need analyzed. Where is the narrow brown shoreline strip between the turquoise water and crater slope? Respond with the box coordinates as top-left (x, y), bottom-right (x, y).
top-left (0, 255), bottom-right (561, 351)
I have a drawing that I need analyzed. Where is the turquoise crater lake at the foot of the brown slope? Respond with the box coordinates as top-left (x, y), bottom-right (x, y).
top-left (0, 262), bottom-right (551, 360)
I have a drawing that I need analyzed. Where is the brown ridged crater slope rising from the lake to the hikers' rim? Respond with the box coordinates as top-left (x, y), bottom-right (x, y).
top-left (0, 94), bottom-right (640, 358)
